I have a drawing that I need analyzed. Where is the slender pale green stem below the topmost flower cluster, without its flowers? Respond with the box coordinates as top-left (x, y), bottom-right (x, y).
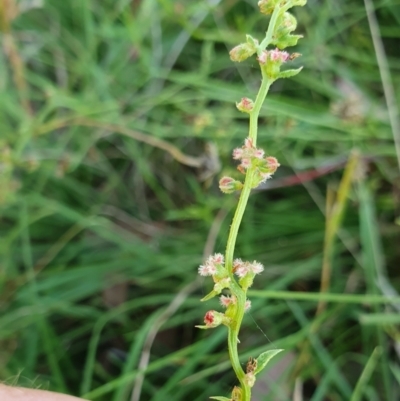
top-left (225, 73), bottom-right (272, 401)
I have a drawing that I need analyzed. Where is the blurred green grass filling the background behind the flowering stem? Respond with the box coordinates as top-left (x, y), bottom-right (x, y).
top-left (0, 0), bottom-right (400, 401)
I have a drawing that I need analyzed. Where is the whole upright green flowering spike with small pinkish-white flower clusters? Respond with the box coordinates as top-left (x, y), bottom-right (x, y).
top-left (197, 0), bottom-right (306, 401)
